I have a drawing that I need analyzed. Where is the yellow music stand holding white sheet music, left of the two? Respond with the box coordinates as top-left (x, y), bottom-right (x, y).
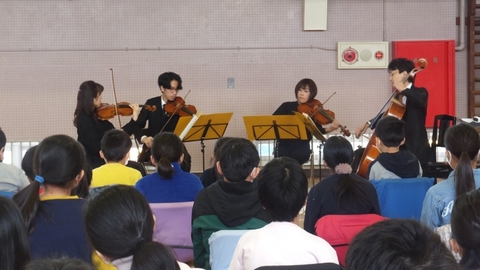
top-left (174, 112), bottom-right (233, 170)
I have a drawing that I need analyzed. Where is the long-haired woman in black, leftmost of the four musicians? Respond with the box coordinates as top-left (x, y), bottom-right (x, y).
top-left (73, 81), bottom-right (140, 169)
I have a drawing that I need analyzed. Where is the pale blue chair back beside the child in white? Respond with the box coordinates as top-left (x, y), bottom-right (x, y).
top-left (208, 230), bottom-right (249, 270)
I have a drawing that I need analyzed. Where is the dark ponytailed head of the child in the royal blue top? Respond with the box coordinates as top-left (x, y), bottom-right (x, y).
top-left (151, 132), bottom-right (183, 179)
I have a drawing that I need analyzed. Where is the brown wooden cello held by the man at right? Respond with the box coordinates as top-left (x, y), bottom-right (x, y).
top-left (357, 58), bottom-right (427, 178)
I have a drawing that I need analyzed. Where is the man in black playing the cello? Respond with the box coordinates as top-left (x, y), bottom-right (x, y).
top-left (352, 58), bottom-right (430, 170)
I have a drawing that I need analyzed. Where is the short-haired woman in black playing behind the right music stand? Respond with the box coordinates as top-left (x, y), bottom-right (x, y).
top-left (273, 79), bottom-right (340, 164)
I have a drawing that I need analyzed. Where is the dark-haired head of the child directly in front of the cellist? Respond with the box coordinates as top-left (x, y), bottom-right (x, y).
top-left (375, 115), bottom-right (405, 147)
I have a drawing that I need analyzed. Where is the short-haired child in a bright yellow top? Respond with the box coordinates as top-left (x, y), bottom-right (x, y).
top-left (91, 129), bottom-right (142, 188)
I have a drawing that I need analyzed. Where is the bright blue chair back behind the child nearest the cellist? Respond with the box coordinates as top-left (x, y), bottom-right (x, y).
top-left (370, 177), bottom-right (435, 221)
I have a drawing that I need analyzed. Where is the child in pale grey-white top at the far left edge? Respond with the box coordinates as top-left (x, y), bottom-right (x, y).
top-left (0, 128), bottom-right (30, 194)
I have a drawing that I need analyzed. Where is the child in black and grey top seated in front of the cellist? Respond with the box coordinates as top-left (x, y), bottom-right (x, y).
top-left (367, 116), bottom-right (422, 180)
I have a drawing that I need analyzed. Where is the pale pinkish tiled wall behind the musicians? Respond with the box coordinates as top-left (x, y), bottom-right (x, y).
top-left (0, 0), bottom-right (467, 171)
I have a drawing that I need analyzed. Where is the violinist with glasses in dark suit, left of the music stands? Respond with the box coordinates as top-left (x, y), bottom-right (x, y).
top-left (135, 72), bottom-right (191, 172)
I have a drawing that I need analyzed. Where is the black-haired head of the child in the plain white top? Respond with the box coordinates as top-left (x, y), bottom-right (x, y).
top-left (256, 157), bottom-right (308, 221)
